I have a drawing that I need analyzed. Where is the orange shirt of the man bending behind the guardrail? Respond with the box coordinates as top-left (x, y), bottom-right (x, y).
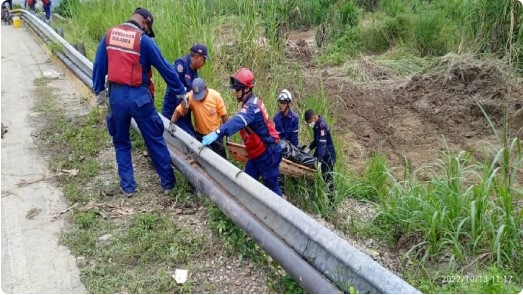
top-left (176, 88), bottom-right (227, 135)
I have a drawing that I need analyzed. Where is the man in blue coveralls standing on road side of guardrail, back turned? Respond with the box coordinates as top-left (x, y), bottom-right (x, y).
top-left (93, 7), bottom-right (188, 197)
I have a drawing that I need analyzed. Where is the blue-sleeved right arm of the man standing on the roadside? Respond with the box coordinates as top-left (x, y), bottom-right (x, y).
top-left (141, 34), bottom-right (187, 95)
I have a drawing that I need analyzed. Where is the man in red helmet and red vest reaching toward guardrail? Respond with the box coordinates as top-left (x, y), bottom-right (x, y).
top-left (202, 68), bottom-right (282, 196)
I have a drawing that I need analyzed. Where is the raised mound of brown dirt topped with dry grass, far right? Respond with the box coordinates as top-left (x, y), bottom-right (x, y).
top-left (395, 58), bottom-right (508, 124)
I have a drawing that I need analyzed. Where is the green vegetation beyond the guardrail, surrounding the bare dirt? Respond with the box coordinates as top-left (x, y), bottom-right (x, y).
top-left (50, 0), bottom-right (523, 293)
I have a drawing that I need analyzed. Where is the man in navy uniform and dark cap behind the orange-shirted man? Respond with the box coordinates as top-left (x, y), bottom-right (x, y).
top-left (162, 43), bottom-right (209, 137)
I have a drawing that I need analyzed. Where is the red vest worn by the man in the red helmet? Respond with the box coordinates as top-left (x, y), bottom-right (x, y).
top-left (240, 99), bottom-right (280, 160)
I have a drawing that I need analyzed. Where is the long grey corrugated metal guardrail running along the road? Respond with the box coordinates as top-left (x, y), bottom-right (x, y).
top-left (22, 11), bottom-right (420, 294)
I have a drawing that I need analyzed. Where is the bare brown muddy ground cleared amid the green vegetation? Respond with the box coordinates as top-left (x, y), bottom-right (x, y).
top-left (288, 31), bottom-right (523, 171)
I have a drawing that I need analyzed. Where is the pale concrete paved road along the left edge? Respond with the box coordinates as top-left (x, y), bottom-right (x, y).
top-left (1, 24), bottom-right (86, 294)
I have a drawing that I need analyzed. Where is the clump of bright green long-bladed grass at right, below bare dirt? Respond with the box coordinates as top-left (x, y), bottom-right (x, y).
top-left (378, 138), bottom-right (523, 273)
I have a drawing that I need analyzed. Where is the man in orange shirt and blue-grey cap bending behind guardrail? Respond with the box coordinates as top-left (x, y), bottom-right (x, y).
top-left (171, 78), bottom-right (229, 159)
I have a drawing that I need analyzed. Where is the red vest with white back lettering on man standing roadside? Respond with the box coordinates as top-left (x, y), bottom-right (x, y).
top-left (105, 25), bottom-right (143, 86)
